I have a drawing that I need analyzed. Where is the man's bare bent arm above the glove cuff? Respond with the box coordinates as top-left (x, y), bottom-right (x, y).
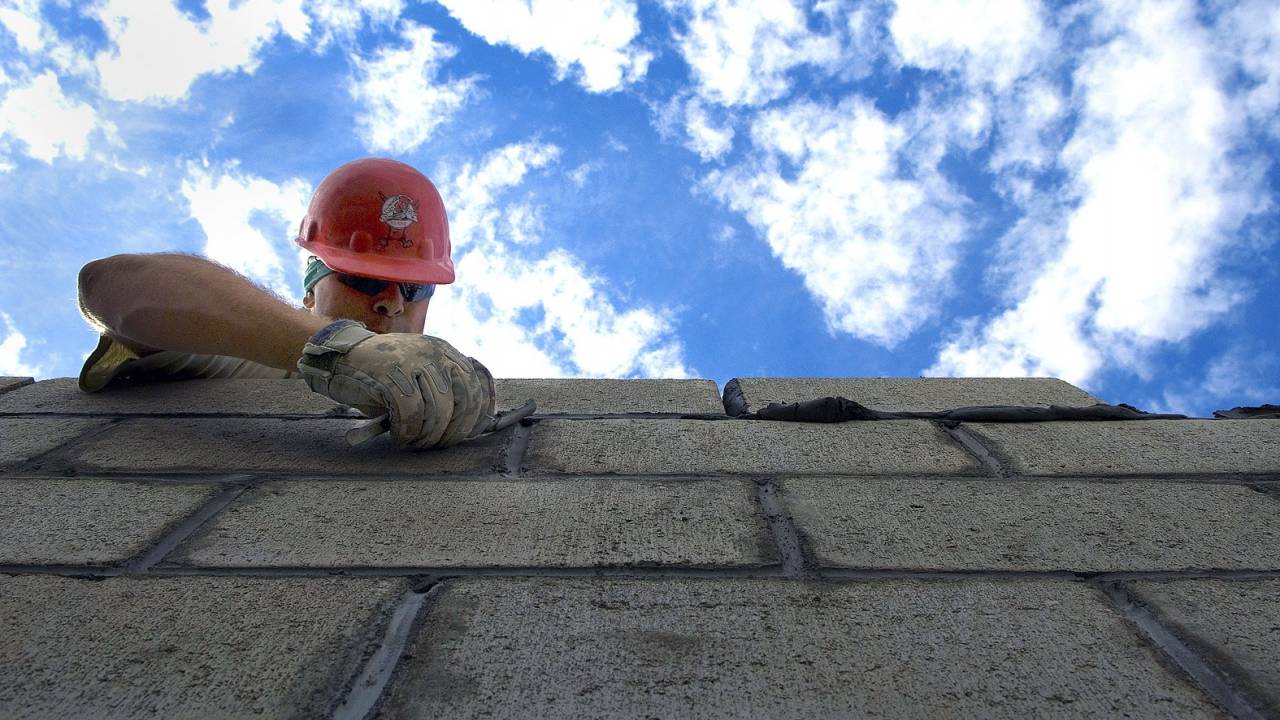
top-left (79, 254), bottom-right (330, 370)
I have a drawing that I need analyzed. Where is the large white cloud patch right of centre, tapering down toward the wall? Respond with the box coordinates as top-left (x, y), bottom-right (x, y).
top-left (705, 97), bottom-right (966, 346)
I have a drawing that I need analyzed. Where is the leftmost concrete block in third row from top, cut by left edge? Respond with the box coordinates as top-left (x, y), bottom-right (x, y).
top-left (0, 478), bottom-right (218, 565)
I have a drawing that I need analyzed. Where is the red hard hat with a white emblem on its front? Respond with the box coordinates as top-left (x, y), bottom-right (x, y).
top-left (296, 158), bottom-right (453, 284)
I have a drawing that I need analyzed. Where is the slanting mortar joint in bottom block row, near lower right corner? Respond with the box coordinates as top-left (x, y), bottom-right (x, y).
top-left (1100, 582), bottom-right (1265, 720)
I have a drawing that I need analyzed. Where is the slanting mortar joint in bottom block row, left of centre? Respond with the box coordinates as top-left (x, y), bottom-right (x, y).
top-left (332, 580), bottom-right (444, 720)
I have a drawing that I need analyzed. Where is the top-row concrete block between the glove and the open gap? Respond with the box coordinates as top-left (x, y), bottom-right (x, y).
top-left (494, 378), bottom-right (724, 415)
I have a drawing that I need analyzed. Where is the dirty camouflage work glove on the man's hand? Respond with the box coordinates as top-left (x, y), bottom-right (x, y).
top-left (298, 320), bottom-right (494, 447)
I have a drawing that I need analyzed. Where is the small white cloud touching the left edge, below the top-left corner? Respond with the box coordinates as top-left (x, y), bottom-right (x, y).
top-left (0, 70), bottom-right (106, 163)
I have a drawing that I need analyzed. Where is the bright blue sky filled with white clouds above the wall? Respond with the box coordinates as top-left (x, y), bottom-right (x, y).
top-left (0, 0), bottom-right (1280, 415)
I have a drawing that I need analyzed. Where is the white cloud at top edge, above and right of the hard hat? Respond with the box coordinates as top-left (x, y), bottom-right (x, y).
top-left (440, 0), bottom-right (653, 92)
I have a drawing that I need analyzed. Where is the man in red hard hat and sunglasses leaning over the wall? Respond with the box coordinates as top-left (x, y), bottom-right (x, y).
top-left (79, 158), bottom-right (494, 447)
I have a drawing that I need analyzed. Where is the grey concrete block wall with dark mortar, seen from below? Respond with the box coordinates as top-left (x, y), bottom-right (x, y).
top-left (0, 378), bottom-right (1280, 717)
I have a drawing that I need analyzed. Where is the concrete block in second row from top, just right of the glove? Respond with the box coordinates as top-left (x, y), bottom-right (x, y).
top-left (525, 419), bottom-right (979, 475)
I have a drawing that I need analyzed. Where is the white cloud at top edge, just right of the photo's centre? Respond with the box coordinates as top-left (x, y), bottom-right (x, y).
top-left (664, 0), bottom-right (842, 105)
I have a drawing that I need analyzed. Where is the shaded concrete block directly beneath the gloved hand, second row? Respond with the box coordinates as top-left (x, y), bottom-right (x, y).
top-left (66, 418), bottom-right (511, 475)
